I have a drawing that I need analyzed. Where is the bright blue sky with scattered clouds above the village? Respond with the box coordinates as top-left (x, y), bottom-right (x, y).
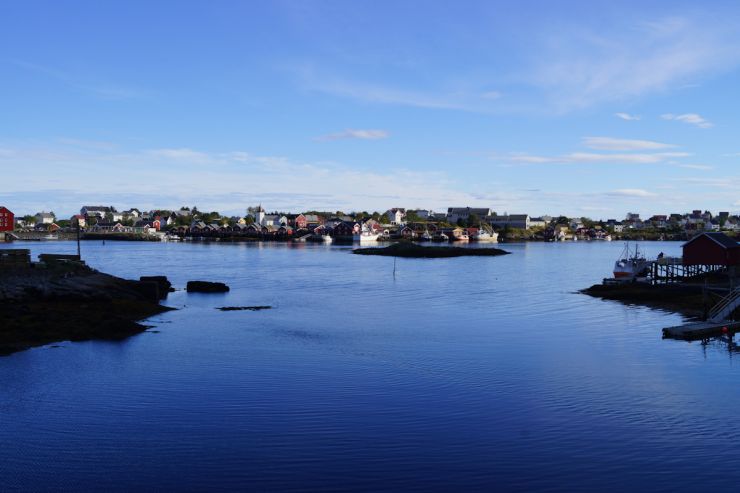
top-left (0, 0), bottom-right (740, 219)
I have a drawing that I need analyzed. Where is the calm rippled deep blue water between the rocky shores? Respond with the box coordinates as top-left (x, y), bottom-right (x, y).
top-left (0, 238), bottom-right (740, 492)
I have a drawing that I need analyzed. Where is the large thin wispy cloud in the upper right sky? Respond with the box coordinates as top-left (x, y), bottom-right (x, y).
top-left (523, 15), bottom-right (740, 111)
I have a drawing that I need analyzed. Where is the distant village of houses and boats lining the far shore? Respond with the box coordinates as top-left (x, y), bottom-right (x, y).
top-left (0, 205), bottom-right (740, 241)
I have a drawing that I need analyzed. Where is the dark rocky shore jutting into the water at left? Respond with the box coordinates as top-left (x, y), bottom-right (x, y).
top-left (0, 262), bottom-right (172, 355)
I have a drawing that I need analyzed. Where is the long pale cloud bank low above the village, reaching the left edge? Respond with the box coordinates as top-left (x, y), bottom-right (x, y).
top-left (0, 143), bottom-right (498, 213)
